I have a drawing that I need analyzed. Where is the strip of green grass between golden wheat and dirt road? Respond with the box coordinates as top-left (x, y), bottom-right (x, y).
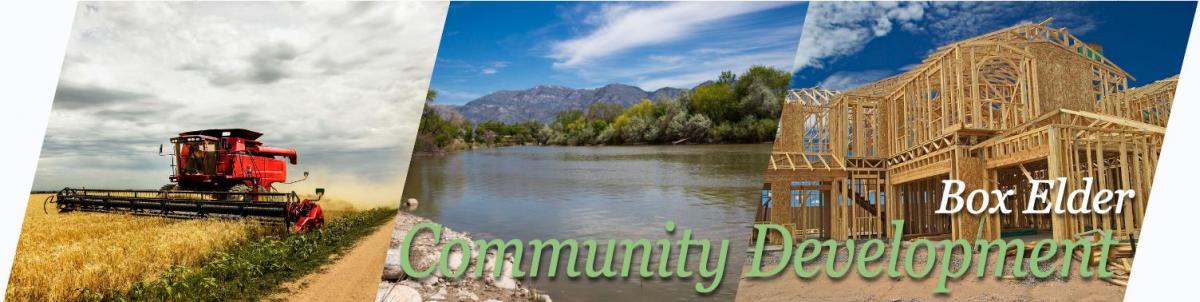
top-left (115, 209), bottom-right (396, 301)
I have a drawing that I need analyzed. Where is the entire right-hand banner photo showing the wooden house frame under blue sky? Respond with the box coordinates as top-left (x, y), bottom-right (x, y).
top-left (738, 2), bottom-right (1195, 301)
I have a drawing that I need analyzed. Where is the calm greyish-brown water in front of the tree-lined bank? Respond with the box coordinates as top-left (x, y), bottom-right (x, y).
top-left (404, 144), bottom-right (770, 301)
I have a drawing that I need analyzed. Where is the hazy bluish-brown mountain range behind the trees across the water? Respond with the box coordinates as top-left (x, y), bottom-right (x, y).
top-left (457, 84), bottom-right (684, 123)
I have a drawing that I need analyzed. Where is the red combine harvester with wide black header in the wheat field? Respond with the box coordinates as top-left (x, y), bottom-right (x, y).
top-left (55, 129), bottom-right (325, 231)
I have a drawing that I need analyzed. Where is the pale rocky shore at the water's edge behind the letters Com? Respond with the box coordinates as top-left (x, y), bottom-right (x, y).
top-left (376, 208), bottom-right (551, 302)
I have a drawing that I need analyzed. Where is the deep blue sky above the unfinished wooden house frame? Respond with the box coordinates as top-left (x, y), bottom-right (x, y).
top-left (792, 2), bottom-right (1195, 90)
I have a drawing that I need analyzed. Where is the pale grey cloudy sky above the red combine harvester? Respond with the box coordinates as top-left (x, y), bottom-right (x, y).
top-left (35, 2), bottom-right (446, 206)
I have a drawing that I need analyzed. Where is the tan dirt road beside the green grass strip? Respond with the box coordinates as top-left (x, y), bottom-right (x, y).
top-left (266, 218), bottom-right (396, 301)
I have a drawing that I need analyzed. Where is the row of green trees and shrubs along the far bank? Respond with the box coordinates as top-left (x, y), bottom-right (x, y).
top-left (415, 66), bottom-right (791, 152)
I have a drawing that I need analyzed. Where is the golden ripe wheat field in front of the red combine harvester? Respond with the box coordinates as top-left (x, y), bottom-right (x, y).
top-left (5, 194), bottom-right (262, 301)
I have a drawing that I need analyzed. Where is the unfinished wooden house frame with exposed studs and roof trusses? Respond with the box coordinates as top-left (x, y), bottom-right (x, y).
top-left (756, 20), bottom-right (1177, 242)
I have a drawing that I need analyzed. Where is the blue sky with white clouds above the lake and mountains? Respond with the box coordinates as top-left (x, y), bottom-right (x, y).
top-left (431, 2), bottom-right (805, 104)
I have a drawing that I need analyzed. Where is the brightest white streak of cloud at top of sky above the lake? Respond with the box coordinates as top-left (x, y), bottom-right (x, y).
top-left (550, 2), bottom-right (782, 68)
